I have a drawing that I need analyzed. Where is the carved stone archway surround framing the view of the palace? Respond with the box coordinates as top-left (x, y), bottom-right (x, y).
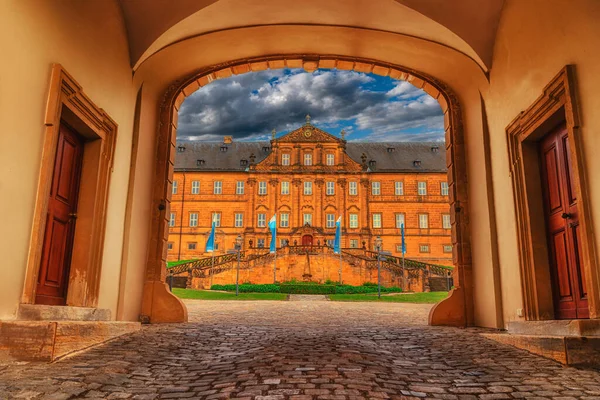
top-left (142, 54), bottom-right (473, 326)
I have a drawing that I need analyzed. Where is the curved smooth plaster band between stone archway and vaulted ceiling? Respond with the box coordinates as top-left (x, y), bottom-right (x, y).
top-left (135, 25), bottom-right (487, 98)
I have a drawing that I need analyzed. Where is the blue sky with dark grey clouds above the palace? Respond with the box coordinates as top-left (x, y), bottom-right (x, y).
top-left (177, 69), bottom-right (444, 141)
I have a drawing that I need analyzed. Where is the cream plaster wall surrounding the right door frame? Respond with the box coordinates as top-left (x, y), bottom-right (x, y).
top-left (485, 0), bottom-right (600, 323)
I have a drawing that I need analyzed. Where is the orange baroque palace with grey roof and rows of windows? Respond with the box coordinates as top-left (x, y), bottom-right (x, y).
top-left (168, 116), bottom-right (452, 265)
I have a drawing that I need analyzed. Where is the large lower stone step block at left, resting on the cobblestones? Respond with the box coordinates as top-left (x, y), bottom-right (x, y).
top-left (0, 321), bottom-right (141, 361)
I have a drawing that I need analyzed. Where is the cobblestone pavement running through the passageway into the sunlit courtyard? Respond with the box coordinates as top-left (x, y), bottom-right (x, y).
top-left (0, 301), bottom-right (600, 400)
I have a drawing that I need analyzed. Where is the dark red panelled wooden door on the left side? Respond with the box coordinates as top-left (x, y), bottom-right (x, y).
top-left (35, 125), bottom-right (83, 305)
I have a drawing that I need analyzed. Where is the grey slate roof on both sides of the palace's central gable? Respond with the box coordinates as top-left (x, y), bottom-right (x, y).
top-left (175, 141), bottom-right (446, 172)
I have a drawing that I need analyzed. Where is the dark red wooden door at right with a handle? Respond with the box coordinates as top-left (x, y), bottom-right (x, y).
top-left (540, 125), bottom-right (589, 319)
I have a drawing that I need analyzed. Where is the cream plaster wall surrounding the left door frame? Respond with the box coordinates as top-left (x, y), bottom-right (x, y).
top-left (0, 0), bottom-right (135, 319)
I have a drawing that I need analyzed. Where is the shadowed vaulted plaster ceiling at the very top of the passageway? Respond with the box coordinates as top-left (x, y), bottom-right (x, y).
top-left (119, 0), bottom-right (504, 71)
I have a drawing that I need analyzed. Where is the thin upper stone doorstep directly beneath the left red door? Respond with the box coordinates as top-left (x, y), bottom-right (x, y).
top-left (17, 304), bottom-right (111, 321)
